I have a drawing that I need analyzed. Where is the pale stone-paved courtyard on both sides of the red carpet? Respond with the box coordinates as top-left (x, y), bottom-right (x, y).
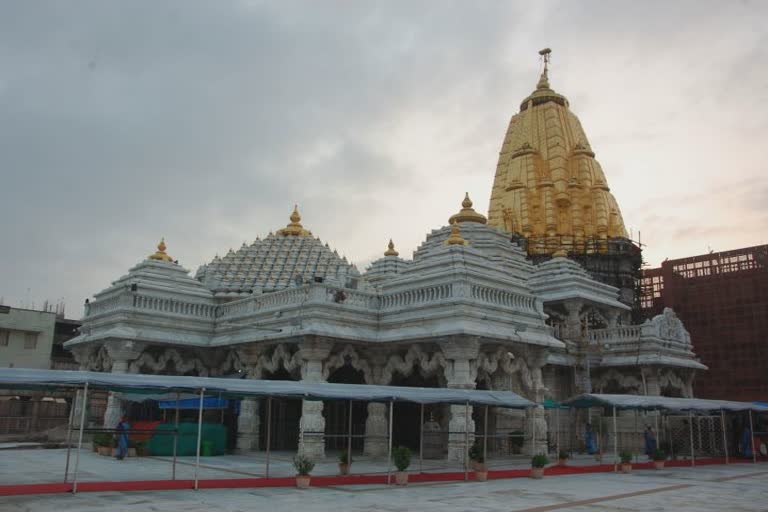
top-left (0, 450), bottom-right (768, 512)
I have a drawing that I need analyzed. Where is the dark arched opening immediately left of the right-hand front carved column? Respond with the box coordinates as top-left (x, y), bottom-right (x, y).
top-left (391, 372), bottom-right (449, 453)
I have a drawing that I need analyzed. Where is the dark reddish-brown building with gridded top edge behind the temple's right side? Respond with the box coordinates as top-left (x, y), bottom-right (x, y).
top-left (641, 245), bottom-right (768, 400)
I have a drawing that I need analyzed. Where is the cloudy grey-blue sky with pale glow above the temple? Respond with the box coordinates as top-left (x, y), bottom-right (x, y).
top-left (0, 0), bottom-right (768, 317)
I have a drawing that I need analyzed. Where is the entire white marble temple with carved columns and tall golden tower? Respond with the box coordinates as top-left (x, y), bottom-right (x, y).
top-left (67, 50), bottom-right (706, 460)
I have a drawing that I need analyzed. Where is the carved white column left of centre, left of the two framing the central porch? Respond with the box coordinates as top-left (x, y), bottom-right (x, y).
top-left (299, 338), bottom-right (333, 460)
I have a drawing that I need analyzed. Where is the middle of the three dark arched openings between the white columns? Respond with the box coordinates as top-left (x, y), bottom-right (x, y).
top-left (323, 364), bottom-right (368, 452)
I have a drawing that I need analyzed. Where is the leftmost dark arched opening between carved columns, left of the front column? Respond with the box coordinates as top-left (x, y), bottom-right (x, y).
top-left (259, 368), bottom-right (301, 451)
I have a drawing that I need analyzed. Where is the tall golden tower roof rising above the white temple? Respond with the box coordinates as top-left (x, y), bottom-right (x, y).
top-left (488, 50), bottom-right (627, 254)
